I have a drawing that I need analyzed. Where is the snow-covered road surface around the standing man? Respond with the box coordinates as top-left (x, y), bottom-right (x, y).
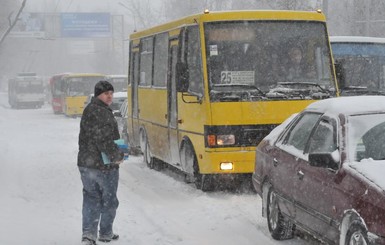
top-left (0, 93), bottom-right (317, 245)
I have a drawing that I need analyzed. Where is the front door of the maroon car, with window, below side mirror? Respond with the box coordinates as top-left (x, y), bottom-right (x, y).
top-left (295, 116), bottom-right (338, 239)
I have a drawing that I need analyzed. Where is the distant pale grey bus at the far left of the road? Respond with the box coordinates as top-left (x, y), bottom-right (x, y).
top-left (8, 72), bottom-right (45, 108)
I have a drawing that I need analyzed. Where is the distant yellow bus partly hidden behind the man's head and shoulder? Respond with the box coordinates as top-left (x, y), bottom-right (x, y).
top-left (62, 73), bottom-right (106, 117)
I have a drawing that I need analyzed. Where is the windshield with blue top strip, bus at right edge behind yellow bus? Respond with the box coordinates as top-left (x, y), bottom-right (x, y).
top-left (332, 42), bottom-right (385, 93)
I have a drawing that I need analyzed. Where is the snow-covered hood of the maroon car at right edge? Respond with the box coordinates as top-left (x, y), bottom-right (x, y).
top-left (349, 159), bottom-right (385, 192)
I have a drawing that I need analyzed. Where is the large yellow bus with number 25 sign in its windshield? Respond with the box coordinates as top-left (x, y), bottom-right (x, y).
top-left (127, 11), bottom-right (338, 191)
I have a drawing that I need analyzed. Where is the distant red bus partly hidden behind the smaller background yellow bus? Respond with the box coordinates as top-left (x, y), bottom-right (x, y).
top-left (49, 73), bottom-right (69, 114)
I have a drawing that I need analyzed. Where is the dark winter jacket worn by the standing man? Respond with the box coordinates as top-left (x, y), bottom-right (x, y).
top-left (78, 97), bottom-right (124, 170)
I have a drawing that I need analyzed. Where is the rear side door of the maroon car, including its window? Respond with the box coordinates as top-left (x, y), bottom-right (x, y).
top-left (270, 113), bottom-right (321, 218)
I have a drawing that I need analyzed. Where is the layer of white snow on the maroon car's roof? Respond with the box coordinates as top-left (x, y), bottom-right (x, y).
top-left (306, 95), bottom-right (385, 115)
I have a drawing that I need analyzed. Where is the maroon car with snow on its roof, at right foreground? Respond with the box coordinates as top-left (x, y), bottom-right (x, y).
top-left (252, 96), bottom-right (385, 245)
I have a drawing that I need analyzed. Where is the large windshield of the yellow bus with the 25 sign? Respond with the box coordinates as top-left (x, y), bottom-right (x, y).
top-left (205, 21), bottom-right (334, 101)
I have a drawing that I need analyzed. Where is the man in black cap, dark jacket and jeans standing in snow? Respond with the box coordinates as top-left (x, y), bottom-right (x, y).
top-left (77, 81), bottom-right (124, 245)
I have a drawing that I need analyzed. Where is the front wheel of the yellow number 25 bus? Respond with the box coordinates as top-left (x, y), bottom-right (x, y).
top-left (182, 143), bottom-right (214, 191)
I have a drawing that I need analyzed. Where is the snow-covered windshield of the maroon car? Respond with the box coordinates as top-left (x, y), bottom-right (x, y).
top-left (347, 113), bottom-right (385, 161)
